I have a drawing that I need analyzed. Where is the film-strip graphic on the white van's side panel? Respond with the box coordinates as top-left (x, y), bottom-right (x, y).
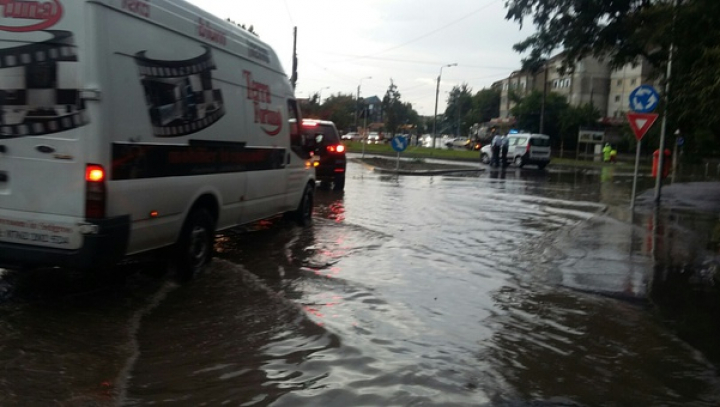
top-left (135, 47), bottom-right (225, 137)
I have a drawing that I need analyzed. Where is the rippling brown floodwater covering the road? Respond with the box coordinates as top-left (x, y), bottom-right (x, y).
top-left (0, 159), bottom-right (720, 407)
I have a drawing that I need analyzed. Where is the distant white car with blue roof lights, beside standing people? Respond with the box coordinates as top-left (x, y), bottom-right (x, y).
top-left (480, 133), bottom-right (550, 169)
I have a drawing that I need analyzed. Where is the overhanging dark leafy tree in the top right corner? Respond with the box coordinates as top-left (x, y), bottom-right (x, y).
top-left (506, 0), bottom-right (720, 153)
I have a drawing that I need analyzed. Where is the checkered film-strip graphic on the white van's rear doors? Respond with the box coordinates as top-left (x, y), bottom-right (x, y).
top-left (0, 30), bottom-right (88, 139)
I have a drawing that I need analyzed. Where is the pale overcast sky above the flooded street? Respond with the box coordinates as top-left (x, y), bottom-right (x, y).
top-left (190, 0), bottom-right (533, 116)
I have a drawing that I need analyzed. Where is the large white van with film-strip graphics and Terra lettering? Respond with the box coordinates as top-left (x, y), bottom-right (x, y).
top-left (0, 0), bottom-right (315, 277)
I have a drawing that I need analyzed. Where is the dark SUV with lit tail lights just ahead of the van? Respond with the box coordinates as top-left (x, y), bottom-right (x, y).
top-left (302, 119), bottom-right (347, 191)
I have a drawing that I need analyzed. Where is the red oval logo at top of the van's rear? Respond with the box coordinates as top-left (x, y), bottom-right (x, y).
top-left (0, 0), bottom-right (63, 32)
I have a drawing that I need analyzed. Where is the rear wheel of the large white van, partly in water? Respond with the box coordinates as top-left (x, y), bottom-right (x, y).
top-left (172, 208), bottom-right (215, 281)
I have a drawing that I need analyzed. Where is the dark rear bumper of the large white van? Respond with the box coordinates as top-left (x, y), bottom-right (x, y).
top-left (0, 215), bottom-right (130, 270)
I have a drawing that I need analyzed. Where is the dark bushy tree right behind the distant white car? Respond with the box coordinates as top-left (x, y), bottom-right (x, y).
top-left (511, 91), bottom-right (569, 146)
